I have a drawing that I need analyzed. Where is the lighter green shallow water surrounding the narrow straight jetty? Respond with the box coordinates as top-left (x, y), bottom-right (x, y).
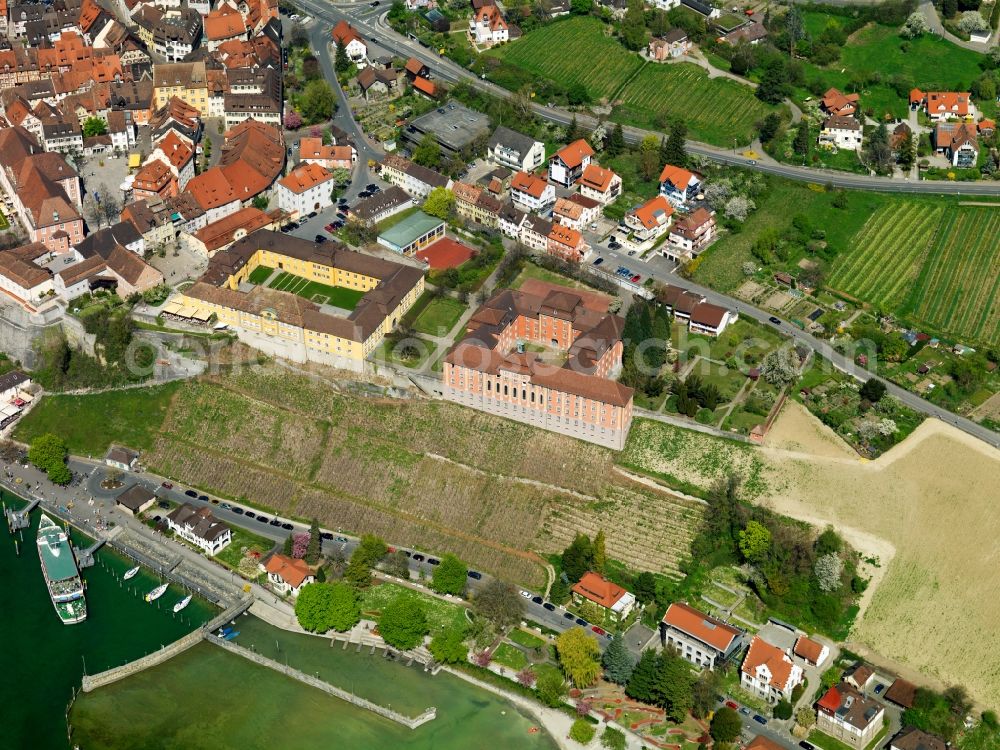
top-left (72, 617), bottom-right (556, 750)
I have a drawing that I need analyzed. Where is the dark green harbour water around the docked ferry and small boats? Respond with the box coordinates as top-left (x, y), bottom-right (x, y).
top-left (0, 493), bottom-right (217, 750)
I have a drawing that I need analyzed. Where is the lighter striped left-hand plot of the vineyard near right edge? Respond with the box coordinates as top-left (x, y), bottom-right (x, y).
top-left (830, 201), bottom-right (944, 310)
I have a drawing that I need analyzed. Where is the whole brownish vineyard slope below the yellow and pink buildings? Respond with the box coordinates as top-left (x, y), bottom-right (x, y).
top-left (146, 367), bottom-right (702, 586)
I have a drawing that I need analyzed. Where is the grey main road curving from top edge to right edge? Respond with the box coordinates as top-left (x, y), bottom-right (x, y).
top-left (296, 0), bottom-right (1000, 195)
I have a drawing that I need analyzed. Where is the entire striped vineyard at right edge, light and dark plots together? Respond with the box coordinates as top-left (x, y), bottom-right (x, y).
top-left (829, 204), bottom-right (1000, 344)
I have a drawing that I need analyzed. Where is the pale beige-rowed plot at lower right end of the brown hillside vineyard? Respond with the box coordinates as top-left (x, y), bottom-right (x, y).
top-left (538, 487), bottom-right (704, 576)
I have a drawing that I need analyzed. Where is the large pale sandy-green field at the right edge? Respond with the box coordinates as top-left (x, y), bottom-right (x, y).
top-left (760, 402), bottom-right (1000, 704)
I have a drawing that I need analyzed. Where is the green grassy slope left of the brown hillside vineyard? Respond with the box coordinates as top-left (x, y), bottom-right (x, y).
top-left (14, 382), bottom-right (181, 456)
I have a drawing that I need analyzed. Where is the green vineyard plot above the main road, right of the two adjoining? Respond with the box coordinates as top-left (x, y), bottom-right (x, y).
top-left (611, 63), bottom-right (774, 146)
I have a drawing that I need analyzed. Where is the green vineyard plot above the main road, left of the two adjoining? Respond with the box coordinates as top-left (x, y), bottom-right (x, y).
top-left (496, 17), bottom-right (642, 99)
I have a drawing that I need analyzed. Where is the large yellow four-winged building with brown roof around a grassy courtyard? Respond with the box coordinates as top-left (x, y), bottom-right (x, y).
top-left (172, 230), bottom-right (424, 370)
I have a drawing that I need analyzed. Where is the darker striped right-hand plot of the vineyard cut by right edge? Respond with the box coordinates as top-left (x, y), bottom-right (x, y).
top-left (911, 206), bottom-right (1000, 344)
